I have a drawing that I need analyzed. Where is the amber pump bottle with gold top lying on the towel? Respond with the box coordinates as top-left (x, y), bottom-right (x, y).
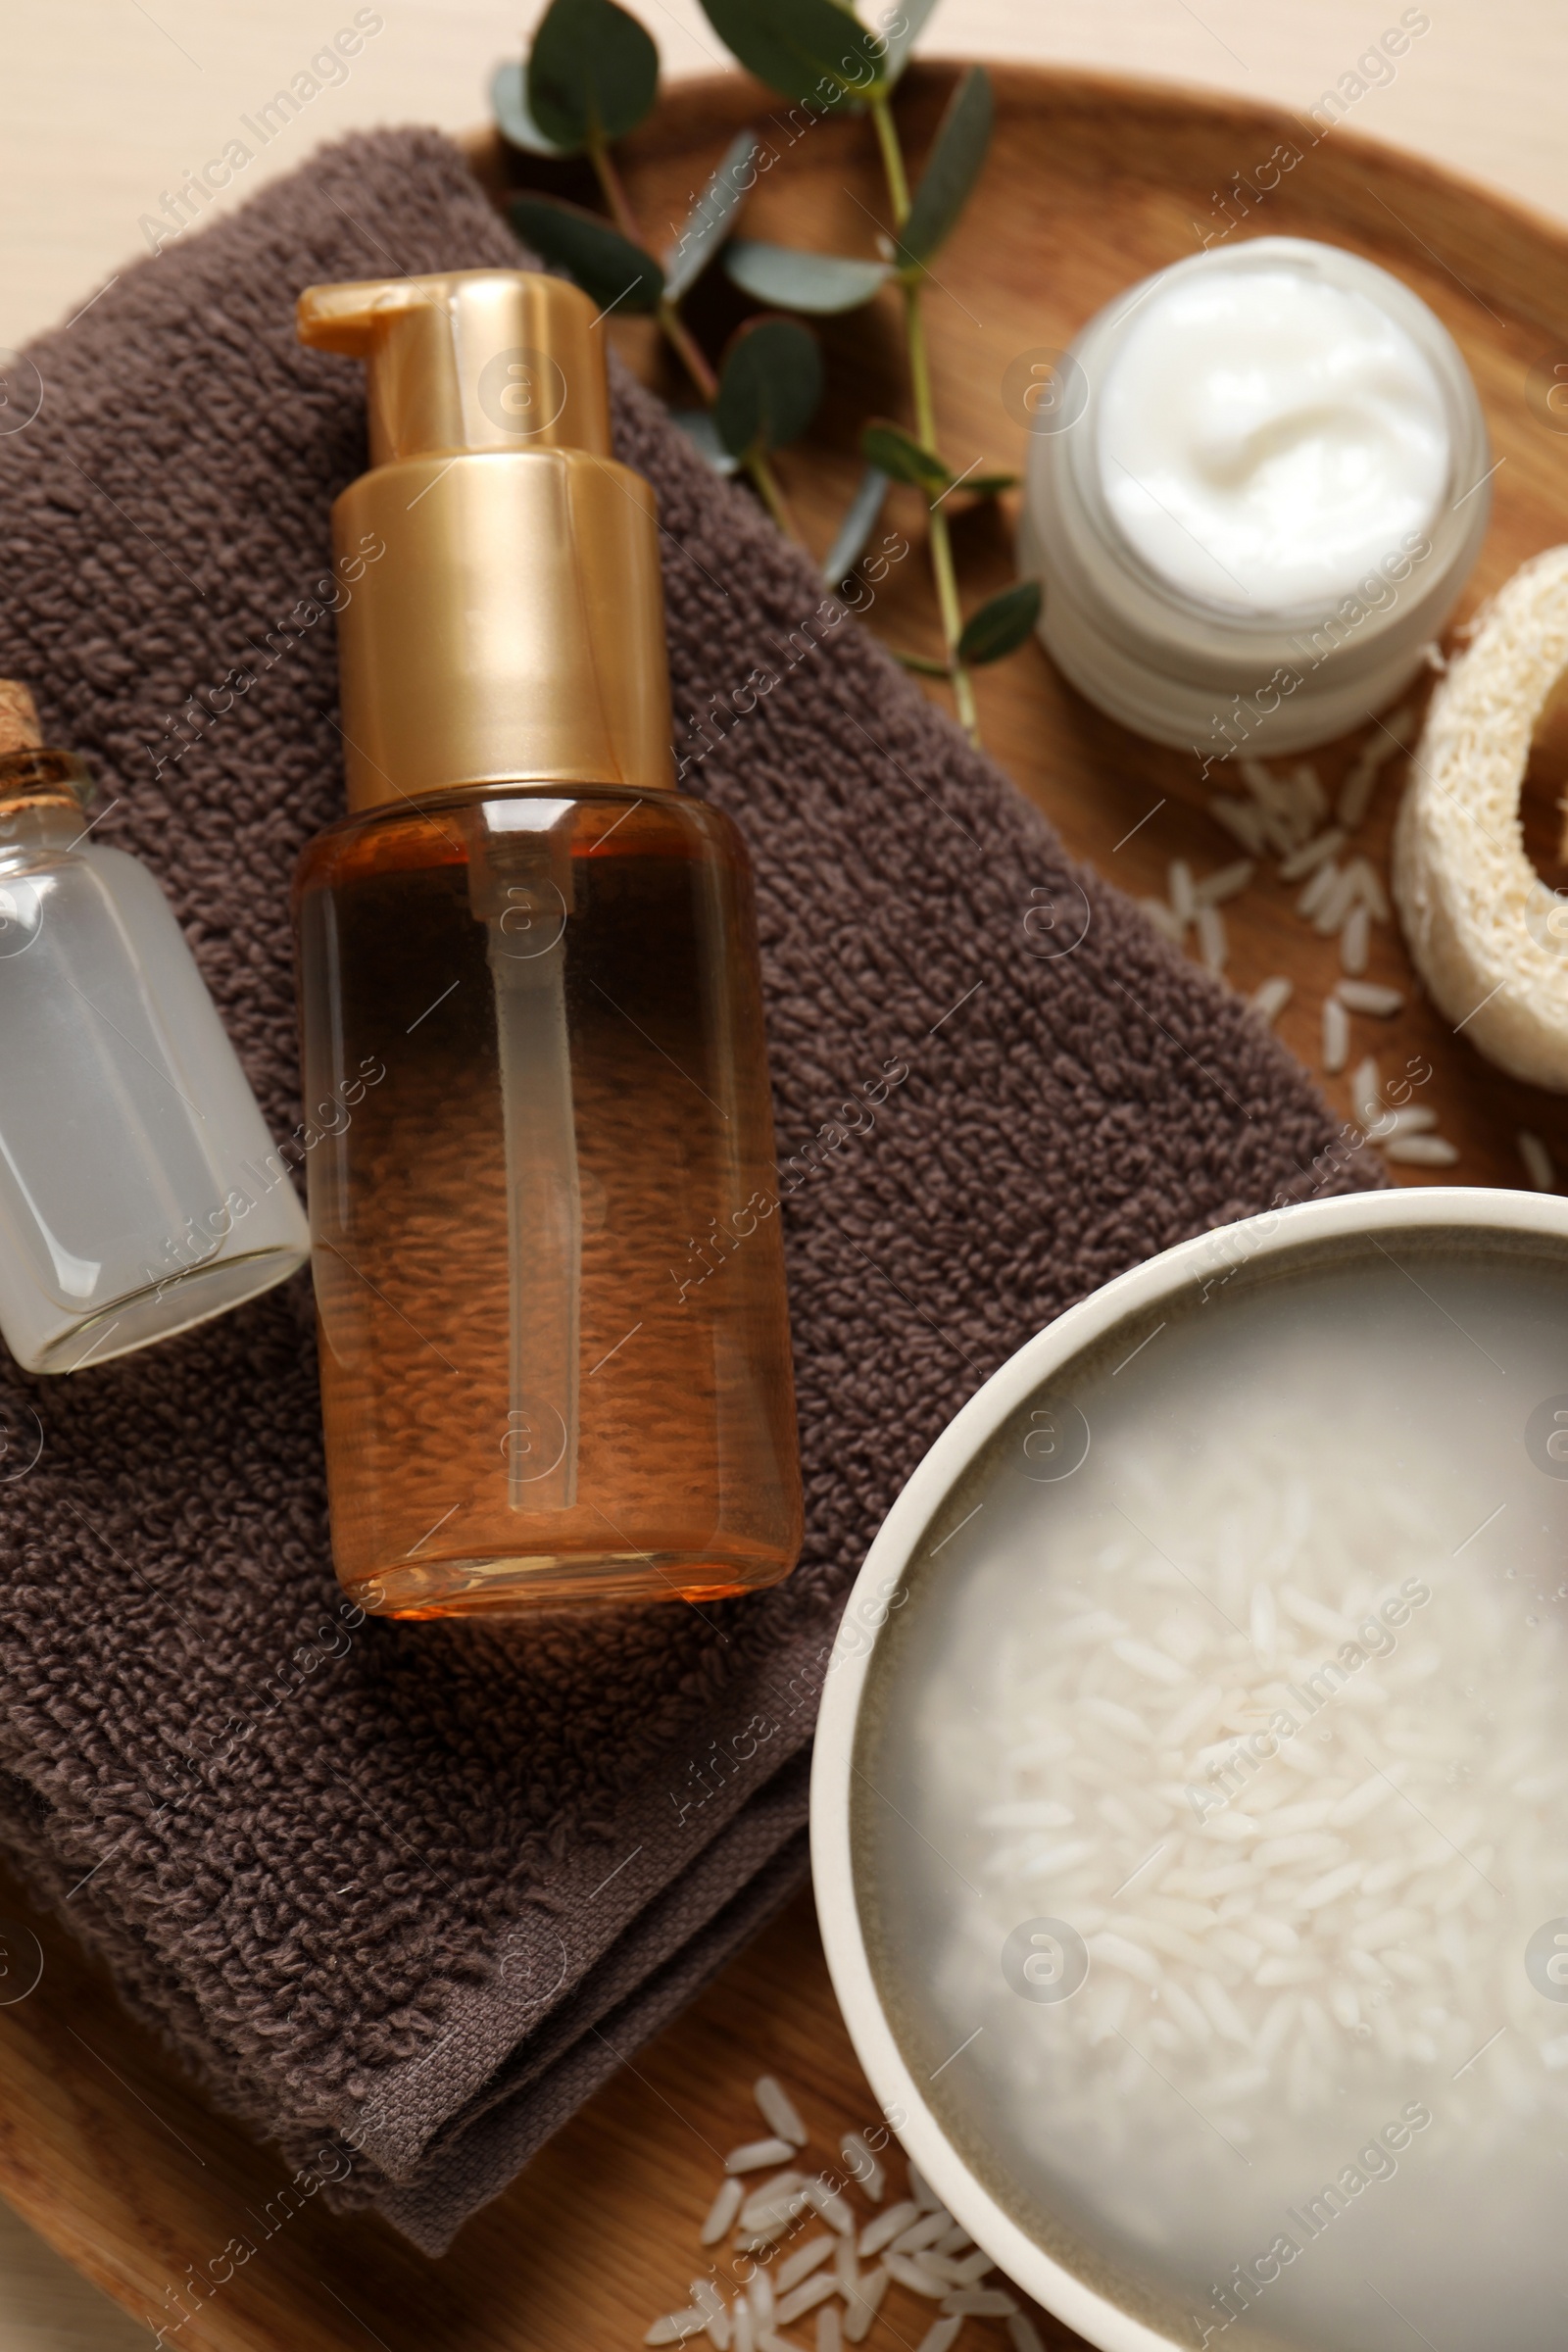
top-left (296, 270), bottom-right (802, 1616)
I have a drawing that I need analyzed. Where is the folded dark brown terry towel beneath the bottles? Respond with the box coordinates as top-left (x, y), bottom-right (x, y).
top-left (0, 131), bottom-right (1378, 2251)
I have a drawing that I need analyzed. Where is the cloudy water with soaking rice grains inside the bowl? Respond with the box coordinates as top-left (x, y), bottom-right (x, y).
top-left (856, 1235), bottom-right (1568, 2352)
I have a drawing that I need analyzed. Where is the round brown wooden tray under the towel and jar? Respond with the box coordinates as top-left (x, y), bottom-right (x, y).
top-left (0, 64), bottom-right (1568, 2352)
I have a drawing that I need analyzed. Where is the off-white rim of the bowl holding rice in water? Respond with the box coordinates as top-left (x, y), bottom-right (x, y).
top-left (811, 1186), bottom-right (1568, 2352)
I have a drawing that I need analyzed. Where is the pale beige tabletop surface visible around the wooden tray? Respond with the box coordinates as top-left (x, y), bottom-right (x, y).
top-left (0, 0), bottom-right (1568, 2352)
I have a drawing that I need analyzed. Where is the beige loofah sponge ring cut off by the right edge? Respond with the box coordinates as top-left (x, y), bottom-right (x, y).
top-left (1394, 548), bottom-right (1568, 1094)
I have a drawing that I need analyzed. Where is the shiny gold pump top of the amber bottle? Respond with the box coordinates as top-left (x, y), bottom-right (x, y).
top-left (299, 270), bottom-right (674, 813)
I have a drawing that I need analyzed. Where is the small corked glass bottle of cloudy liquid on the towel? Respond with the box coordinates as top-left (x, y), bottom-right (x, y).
top-left (0, 680), bottom-right (308, 1371)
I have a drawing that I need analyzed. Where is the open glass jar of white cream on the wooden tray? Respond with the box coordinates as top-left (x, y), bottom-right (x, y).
top-left (1018, 237), bottom-right (1491, 760)
